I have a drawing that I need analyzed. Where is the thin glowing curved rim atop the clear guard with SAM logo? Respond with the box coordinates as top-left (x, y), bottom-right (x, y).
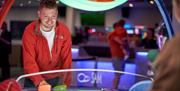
top-left (16, 69), bottom-right (153, 82)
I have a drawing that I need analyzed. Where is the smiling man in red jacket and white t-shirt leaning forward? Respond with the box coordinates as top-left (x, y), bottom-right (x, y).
top-left (22, 0), bottom-right (72, 87)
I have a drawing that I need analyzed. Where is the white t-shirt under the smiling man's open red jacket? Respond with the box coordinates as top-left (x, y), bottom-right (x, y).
top-left (40, 28), bottom-right (55, 56)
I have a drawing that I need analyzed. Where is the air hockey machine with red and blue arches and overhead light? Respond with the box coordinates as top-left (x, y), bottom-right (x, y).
top-left (0, 0), bottom-right (174, 91)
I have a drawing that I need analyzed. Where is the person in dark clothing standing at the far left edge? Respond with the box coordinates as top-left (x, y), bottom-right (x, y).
top-left (0, 22), bottom-right (11, 81)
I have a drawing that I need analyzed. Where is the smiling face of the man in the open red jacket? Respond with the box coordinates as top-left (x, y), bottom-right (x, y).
top-left (38, 7), bottom-right (58, 30)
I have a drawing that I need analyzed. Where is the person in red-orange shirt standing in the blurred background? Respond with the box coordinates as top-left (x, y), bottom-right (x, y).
top-left (108, 20), bottom-right (127, 89)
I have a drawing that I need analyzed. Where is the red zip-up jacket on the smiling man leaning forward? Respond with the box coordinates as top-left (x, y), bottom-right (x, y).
top-left (22, 20), bottom-right (72, 86)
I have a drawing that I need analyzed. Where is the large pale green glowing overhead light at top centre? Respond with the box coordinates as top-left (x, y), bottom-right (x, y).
top-left (59, 0), bottom-right (128, 11)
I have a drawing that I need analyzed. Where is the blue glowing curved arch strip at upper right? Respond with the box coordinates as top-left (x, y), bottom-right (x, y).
top-left (154, 0), bottom-right (174, 38)
